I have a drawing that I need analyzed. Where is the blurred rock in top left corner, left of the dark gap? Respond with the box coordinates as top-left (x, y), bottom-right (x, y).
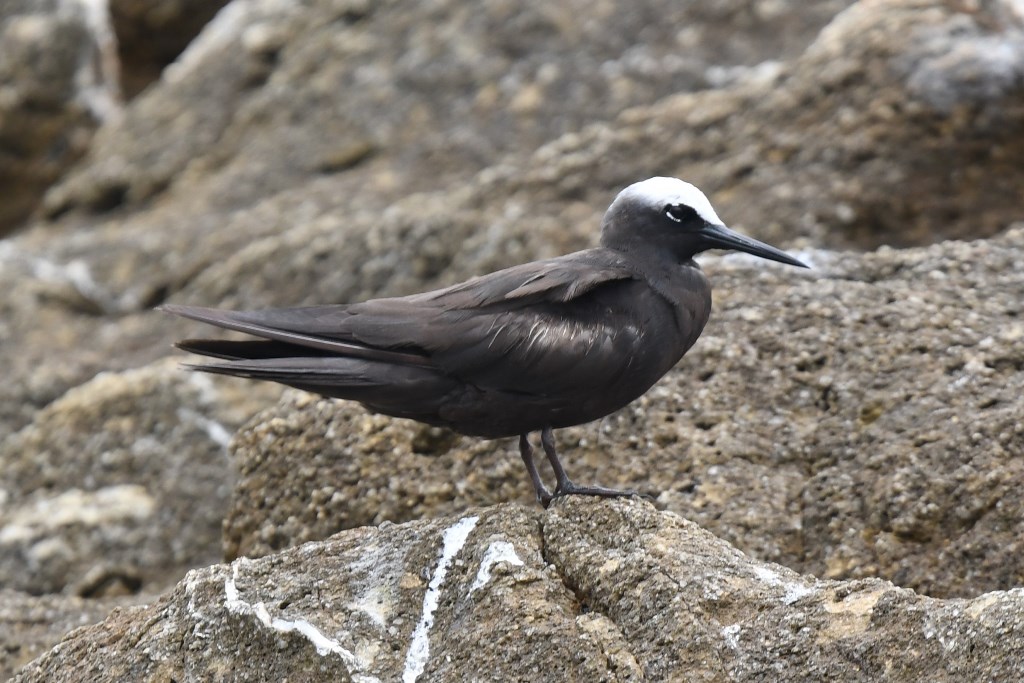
top-left (0, 0), bottom-right (119, 236)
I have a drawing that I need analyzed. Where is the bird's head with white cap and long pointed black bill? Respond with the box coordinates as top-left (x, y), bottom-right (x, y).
top-left (601, 177), bottom-right (807, 268)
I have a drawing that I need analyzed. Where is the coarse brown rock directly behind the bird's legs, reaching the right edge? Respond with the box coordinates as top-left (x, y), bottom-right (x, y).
top-left (224, 225), bottom-right (1024, 596)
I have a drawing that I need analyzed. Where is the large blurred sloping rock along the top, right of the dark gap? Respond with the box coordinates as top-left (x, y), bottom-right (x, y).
top-left (41, 0), bottom-right (849, 219)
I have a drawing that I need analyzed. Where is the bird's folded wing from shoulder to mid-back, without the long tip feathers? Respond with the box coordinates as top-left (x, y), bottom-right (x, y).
top-left (336, 250), bottom-right (665, 393)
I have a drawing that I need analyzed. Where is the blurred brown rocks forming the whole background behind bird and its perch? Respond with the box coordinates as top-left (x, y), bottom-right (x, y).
top-left (0, 0), bottom-right (1024, 680)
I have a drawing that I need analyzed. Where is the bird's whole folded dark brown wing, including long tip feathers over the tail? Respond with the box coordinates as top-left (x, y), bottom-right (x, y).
top-left (165, 250), bottom-right (649, 392)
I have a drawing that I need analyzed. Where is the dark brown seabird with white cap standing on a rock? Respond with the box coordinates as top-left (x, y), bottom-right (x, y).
top-left (161, 177), bottom-right (808, 508)
